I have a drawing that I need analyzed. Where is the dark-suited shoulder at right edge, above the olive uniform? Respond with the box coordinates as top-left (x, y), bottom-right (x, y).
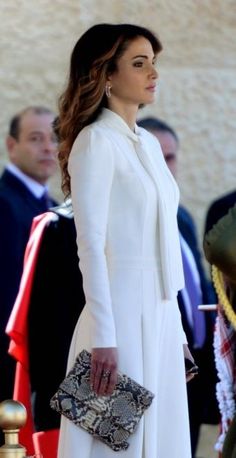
top-left (205, 191), bottom-right (236, 234)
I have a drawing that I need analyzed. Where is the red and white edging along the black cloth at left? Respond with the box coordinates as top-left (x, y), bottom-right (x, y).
top-left (6, 212), bottom-right (56, 458)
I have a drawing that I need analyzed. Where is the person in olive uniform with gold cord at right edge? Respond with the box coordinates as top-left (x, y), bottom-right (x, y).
top-left (203, 206), bottom-right (236, 458)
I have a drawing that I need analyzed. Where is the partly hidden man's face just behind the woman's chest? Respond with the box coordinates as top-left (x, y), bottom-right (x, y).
top-left (152, 130), bottom-right (178, 178)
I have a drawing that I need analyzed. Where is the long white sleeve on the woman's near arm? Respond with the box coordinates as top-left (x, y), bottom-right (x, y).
top-left (69, 127), bottom-right (116, 348)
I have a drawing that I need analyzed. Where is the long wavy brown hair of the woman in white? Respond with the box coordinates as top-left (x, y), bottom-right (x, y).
top-left (55, 24), bottom-right (162, 197)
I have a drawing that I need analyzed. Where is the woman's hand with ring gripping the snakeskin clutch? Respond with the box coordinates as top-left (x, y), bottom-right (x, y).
top-left (90, 347), bottom-right (118, 396)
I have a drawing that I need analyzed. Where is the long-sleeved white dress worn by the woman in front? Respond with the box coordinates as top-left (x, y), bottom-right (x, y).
top-left (58, 109), bottom-right (191, 458)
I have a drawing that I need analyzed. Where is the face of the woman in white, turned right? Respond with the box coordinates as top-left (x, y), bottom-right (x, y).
top-left (108, 37), bottom-right (158, 108)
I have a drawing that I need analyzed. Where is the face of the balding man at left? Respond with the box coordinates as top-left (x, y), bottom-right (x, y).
top-left (7, 111), bottom-right (58, 184)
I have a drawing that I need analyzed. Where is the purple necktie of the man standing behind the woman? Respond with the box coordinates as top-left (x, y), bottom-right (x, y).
top-left (181, 242), bottom-right (206, 348)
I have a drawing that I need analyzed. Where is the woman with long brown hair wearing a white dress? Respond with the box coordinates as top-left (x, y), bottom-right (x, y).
top-left (58, 24), bottom-right (190, 458)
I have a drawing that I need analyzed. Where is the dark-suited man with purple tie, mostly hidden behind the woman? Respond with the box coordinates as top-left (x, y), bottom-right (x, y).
top-left (138, 117), bottom-right (219, 457)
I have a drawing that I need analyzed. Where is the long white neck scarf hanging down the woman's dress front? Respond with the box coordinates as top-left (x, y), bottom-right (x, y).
top-left (97, 109), bottom-right (184, 299)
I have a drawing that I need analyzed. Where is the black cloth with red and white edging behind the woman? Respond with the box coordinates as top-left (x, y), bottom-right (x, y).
top-left (7, 201), bottom-right (85, 458)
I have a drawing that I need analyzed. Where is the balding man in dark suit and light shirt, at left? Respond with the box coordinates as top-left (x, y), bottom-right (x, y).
top-left (0, 107), bottom-right (57, 412)
